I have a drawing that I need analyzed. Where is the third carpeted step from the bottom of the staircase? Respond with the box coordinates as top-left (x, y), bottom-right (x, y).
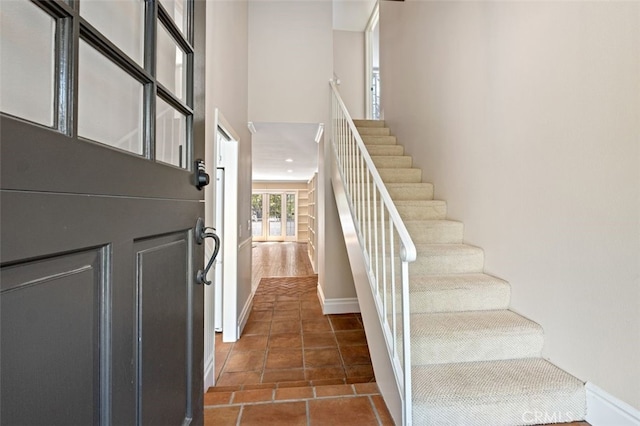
top-left (409, 274), bottom-right (511, 313)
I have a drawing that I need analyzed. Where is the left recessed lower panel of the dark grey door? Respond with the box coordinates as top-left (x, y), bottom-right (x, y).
top-left (0, 249), bottom-right (105, 425)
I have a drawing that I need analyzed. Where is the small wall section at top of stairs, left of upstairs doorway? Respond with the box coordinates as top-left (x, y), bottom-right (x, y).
top-left (333, 30), bottom-right (365, 118)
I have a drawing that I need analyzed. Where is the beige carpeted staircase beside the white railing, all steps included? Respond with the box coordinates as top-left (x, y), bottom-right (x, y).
top-left (354, 120), bottom-right (585, 426)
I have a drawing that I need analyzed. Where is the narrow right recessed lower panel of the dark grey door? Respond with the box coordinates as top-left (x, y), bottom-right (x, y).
top-left (134, 233), bottom-right (191, 425)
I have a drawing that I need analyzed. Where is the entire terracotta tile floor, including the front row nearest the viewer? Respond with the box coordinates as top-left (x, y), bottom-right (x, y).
top-left (205, 276), bottom-right (393, 426)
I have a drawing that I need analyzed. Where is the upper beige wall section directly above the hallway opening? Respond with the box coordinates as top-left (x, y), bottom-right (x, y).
top-left (249, 1), bottom-right (333, 123)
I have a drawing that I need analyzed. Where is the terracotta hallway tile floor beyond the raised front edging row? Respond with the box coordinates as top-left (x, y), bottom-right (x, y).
top-left (216, 276), bottom-right (374, 386)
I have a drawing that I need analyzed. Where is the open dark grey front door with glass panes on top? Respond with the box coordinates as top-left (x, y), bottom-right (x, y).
top-left (0, 0), bottom-right (205, 425)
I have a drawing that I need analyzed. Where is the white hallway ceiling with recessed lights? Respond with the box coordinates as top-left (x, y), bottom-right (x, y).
top-left (251, 123), bottom-right (318, 182)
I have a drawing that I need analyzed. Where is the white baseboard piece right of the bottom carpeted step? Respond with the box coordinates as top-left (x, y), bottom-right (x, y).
top-left (585, 382), bottom-right (640, 426)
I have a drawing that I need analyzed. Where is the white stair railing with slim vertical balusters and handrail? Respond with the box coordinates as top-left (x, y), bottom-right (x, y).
top-left (330, 80), bottom-right (416, 425)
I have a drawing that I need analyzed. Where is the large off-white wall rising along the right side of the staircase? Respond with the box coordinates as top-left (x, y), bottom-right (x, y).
top-left (381, 1), bottom-right (640, 408)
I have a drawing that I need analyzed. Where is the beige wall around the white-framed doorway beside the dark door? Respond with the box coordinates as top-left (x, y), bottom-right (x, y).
top-left (206, 0), bottom-right (251, 320)
